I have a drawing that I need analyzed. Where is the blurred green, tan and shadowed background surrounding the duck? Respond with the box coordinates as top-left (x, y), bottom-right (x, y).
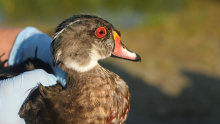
top-left (0, 0), bottom-right (220, 124)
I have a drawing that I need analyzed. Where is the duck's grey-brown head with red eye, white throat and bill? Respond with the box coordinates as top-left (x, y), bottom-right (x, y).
top-left (51, 15), bottom-right (141, 72)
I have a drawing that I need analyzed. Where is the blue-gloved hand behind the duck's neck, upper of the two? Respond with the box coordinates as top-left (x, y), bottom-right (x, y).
top-left (8, 27), bottom-right (66, 87)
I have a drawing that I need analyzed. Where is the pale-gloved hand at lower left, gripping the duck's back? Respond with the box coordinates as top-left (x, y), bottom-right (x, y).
top-left (0, 69), bottom-right (57, 124)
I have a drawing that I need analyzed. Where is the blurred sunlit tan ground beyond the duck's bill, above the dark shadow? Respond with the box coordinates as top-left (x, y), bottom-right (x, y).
top-left (115, 2), bottom-right (220, 96)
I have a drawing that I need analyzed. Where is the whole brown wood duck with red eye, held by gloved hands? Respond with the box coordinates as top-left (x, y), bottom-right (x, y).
top-left (19, 15), bottom-right (141, 124)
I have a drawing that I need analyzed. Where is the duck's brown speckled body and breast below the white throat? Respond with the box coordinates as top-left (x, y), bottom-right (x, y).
top-left (19, 66), bottom-right (130, 124)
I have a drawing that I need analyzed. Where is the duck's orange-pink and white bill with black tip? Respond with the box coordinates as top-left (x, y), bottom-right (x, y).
top-left (111, 31), bottom-right (141, 61)
